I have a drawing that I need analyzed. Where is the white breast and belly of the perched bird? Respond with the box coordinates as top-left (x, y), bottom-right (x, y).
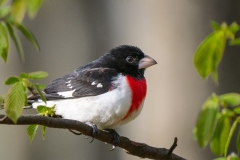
top-left (33, 75), bottom-right (132, 129)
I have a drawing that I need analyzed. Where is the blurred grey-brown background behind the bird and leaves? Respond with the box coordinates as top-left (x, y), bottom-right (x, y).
top-left (0, 0), bottom-right (240, 160)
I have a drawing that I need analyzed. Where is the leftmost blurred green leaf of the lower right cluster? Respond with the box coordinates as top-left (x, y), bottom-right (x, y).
top-left (196, 96), bottom-right (219, 148)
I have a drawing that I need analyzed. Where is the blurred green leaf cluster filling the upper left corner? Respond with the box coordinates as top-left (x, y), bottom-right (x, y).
top-left (0, 0), bottom-right (43, 62)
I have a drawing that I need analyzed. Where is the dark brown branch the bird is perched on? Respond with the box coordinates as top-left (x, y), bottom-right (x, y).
top-left (0, 115), bottom-right (185, 160)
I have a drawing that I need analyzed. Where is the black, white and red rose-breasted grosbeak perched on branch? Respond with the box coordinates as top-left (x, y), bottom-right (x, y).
top-left (30, 45), bottom-right (157, 129)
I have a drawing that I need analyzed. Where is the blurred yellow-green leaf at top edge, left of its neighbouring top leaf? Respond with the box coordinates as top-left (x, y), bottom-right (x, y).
top-left (11, 0), bottom-right (27, 23)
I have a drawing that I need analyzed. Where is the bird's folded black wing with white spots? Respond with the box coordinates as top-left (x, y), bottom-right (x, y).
top-left (44, 68), bottom-right (118, 99)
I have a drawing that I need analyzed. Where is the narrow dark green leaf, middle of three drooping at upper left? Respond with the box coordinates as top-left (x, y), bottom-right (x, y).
top-left (6, 23), bottom-right (24, 61)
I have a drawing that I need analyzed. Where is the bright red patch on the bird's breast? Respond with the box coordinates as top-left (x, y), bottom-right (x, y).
top-left (122, 76), bottom-right (147, 120)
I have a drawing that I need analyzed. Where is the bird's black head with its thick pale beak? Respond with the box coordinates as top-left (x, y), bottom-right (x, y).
top-left (99, 45), bottom-right (157, 78)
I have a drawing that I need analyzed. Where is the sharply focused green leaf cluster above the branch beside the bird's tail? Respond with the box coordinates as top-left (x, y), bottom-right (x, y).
top-left (3, 71), bottom-right (48, 123)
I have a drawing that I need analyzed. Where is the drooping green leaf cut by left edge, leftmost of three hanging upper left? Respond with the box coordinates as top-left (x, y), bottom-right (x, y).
top-left (0, 23), bottom-right (9, 62)
